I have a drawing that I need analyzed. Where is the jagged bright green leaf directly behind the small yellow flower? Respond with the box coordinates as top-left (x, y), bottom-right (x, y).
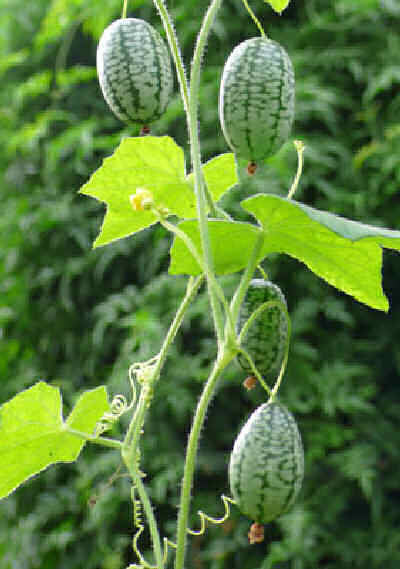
top-left (80, 136), bottom-right (196, 247)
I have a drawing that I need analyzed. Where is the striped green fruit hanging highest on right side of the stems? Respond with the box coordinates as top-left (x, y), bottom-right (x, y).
top-left (219, 37), bottom-right (294, 162)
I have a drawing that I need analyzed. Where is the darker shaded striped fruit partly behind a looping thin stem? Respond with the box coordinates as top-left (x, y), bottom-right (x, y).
top-left (237, 279), bottom-right (289, 379)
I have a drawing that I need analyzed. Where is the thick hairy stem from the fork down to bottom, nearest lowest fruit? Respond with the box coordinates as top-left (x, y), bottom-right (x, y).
top-left (175, 350), bottom-right (235, 569)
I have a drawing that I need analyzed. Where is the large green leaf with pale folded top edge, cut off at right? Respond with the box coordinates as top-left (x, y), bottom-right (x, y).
top-left (242, 194), bottom-right (400, 311)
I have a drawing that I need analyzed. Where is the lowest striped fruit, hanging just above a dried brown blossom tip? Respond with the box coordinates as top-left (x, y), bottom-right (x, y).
top-left (229, 402), bottom-right (304, 524)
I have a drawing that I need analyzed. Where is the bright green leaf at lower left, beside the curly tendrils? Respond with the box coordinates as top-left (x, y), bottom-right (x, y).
top-left (0, 381), bottom-right (109, 498)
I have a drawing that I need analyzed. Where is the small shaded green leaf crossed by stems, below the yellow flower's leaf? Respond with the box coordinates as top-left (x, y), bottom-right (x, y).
top-left (169, 219), bottom-right (261, 275)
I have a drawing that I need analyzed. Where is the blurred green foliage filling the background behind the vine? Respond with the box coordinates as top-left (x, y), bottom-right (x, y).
top-left (0, 0), bottom-right (400, 569)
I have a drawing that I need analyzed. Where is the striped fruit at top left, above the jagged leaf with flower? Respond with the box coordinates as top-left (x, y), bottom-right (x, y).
top-left (97, 18), bottom-right (173, 125)
